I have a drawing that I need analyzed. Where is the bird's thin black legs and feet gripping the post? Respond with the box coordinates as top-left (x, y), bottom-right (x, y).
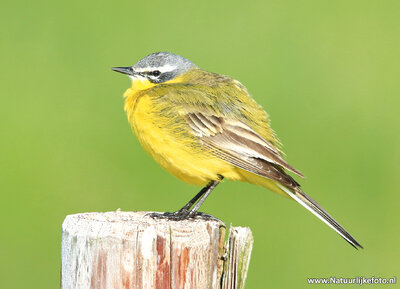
top-left (151, 176), bottom-right (223, 221)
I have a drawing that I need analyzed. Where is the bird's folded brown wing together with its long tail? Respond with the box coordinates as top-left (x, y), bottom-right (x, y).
top-left (186, 112), bottom-right (362, 249)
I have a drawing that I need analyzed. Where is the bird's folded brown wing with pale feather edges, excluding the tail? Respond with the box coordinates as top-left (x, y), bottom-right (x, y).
top-left (186, 112), bottom-right (303, 187)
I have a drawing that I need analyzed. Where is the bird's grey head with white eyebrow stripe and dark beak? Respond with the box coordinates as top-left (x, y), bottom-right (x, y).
top-left (112, 52), bottom-right (196, 83)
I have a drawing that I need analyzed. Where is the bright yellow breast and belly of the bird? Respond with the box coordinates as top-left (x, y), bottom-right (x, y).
top-left (124, 80), bottom-right (239, 186)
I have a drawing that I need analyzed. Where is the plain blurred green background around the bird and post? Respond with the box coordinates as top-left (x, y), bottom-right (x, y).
top-left (0, 0), bottom-right (400, 289)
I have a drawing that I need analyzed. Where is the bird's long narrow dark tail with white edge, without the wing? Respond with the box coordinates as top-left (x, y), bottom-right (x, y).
top-left (278, 184), bottom-right (363, 249)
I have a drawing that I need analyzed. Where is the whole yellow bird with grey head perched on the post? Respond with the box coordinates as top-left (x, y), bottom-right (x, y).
top-left (112, 52), bottom-right (363, 249)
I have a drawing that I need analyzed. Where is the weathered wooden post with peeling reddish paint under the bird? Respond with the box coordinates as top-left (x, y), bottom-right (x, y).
top-left (61, 211), bottom-right (253, 289)
